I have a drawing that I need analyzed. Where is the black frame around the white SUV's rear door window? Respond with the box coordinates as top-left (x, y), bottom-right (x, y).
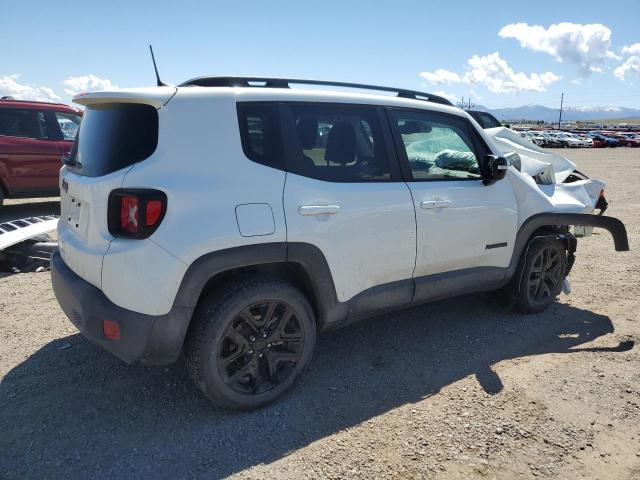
top-left (278, 101), bottom-right (404, 184)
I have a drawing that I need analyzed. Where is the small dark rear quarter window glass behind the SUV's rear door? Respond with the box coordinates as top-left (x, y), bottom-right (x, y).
top-left (238, 103), bottom-right (284, 170)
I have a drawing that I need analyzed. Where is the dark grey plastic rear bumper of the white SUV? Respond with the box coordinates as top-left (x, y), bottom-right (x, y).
top-left (51, 250), bottom-right (193, 365)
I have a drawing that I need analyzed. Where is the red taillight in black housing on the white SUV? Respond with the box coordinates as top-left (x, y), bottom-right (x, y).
top-left (107, 188), bottom-right (167, 238)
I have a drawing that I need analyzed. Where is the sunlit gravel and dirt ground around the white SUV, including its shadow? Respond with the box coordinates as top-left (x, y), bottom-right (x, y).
top-left (0, 148), bottom-right (640, 479)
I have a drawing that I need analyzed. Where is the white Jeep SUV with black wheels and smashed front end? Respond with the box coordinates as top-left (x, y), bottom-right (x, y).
top-left (51, 77), bottom-right (628, 409)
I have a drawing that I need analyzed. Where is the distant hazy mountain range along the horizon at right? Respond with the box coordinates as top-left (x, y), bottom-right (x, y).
top-left (474, 105), bottom-right (640, 122)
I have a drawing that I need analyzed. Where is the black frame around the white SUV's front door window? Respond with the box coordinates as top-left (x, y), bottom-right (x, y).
top-left (385, 107), bottom-right (491, 183)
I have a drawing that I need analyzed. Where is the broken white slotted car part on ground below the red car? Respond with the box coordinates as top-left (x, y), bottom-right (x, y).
top-left (0, 215), bottom-right (58, 273)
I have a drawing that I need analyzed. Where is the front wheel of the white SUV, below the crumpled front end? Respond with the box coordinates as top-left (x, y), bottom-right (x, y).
top-left (516, 240), bottom-right (567, 313)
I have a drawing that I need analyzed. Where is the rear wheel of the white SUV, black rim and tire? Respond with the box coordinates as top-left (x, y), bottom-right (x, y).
top-left (185, 278), bottom-right (316, 410)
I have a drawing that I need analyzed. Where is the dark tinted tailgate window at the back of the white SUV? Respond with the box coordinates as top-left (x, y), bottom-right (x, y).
top-left (69, 103), bottom-right (158, 177)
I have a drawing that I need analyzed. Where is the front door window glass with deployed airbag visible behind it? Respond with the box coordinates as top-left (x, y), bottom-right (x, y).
top-left (392, 111), bottom-right (481, 180)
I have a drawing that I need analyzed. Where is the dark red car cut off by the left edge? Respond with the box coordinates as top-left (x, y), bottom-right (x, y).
top-left (0, 97), bottom-right (82, 205)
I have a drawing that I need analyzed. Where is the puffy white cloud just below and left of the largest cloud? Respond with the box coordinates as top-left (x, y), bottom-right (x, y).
top-left (462, 52), bottom-right (562, 93)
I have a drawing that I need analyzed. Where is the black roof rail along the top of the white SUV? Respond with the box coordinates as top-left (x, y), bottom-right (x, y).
top-left (180, 77), bottom-right (453, 105)
